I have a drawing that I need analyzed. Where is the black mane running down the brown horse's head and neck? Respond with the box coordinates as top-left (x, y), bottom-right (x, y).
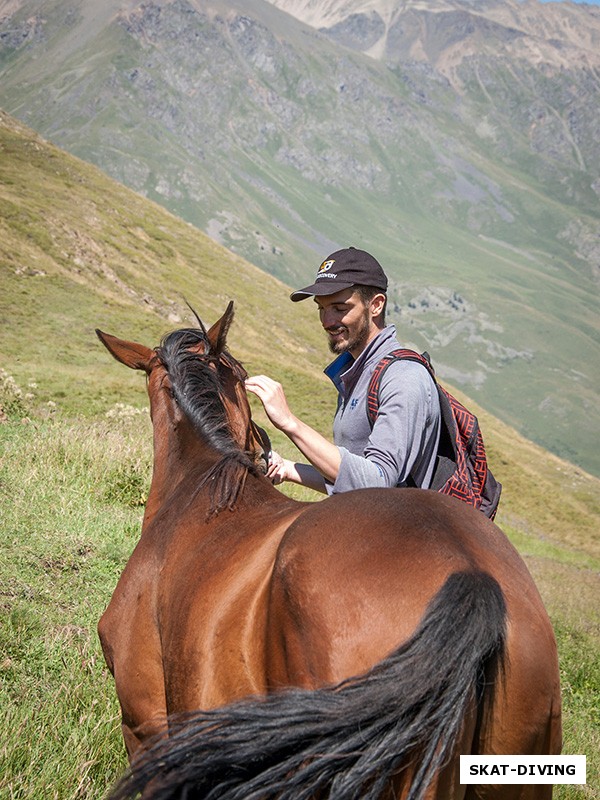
top-left (156, 328), bottom-right (258, 514)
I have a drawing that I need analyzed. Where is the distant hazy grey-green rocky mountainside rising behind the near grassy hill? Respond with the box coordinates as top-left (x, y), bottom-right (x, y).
top-left (0, 0), bottom-right (600, 472)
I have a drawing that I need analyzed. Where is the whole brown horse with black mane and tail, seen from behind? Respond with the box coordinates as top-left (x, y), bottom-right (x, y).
top-left (98, 304), bottom-right (561, 800)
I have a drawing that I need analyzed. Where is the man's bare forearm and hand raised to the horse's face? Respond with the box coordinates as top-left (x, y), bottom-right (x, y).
top-left (246, 375), bottom-right (341, 484)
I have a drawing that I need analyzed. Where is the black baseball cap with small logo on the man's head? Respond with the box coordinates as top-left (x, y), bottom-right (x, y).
top-left (290, 247), bottom-right (388, 303)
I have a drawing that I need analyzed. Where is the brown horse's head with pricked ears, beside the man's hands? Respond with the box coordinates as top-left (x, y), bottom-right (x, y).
top-left (96, 302), bottom-right (270, 506)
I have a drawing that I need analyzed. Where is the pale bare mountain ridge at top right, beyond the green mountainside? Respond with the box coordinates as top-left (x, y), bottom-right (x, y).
top-left (268, 0), bottom-right (600, 79)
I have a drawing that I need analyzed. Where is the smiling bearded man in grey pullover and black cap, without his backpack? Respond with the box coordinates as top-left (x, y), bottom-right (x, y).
top-left (246, 247), bottom-right (440, 493)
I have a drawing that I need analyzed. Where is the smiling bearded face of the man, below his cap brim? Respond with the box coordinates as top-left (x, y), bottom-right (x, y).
top-left (315, 288), bottom-right (378, 358)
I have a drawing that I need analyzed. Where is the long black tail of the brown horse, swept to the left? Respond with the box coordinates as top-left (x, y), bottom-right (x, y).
top-left (111, 572), bottom-right (506, 800)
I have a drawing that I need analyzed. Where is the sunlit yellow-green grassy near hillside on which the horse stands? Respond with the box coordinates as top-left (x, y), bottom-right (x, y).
top-left (0, 112), bottom-right (600, 798)
